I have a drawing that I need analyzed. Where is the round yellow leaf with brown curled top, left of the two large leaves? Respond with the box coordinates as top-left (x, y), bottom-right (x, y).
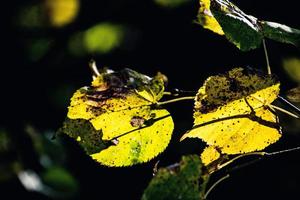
top-left (62, 69), bottom-right (174, 166)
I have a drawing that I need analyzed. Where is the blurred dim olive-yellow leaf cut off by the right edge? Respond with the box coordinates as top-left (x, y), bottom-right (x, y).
top-left (283, 58), bottom-right (300, 83)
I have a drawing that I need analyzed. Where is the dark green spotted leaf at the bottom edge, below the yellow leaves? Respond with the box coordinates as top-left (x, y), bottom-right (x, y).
top-left (142, 155), bottom-right (202, 200)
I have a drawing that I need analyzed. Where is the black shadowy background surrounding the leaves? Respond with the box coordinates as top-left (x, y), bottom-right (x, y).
top-left (0, 0), bottom-right (300, 199)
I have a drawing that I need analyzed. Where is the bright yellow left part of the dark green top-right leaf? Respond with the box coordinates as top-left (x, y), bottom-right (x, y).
top-left (198, 0), bottom-right (224, 35)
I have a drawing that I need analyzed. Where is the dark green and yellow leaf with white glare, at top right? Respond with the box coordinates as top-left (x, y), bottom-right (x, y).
top-left (198, 0), bottom-right (300, 51)
